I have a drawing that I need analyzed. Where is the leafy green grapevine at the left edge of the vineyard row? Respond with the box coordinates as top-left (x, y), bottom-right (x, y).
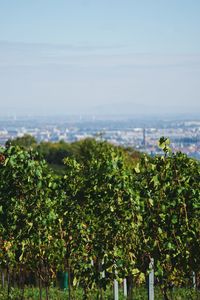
top-left (0, 146), bottom-right (64, 295)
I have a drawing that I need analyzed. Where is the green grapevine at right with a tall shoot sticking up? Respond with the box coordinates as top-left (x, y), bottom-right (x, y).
top-left (135, 138), bottom-right (200, 298)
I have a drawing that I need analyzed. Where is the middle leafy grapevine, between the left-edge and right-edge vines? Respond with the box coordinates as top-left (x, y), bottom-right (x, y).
top-left (62, 140), bottom-right (139, 298)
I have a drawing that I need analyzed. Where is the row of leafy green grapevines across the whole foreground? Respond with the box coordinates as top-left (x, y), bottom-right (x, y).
top-left (0, 138), bottom-right (200, 300)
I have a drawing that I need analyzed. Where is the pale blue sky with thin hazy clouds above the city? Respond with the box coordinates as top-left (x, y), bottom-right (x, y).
top-left (0, 0), bottom-right (200, 115)
